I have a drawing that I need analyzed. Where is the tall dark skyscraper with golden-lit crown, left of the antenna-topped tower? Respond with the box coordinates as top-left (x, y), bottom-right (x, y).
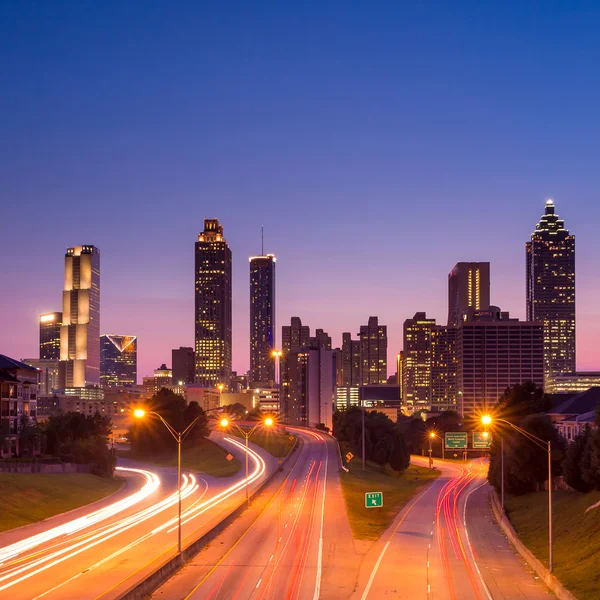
top-left (195, 219), bottom-right (231, 389)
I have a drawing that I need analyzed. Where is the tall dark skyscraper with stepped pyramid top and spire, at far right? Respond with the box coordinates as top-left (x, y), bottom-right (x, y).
top-left (526, 200), bottom-right (576, 380)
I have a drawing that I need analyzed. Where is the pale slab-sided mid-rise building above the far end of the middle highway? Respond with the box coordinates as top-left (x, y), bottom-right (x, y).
top-left (280, 347), bottom-right (335, 428)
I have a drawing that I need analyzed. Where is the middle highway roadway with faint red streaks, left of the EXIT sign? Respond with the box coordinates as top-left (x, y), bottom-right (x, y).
top-left (152, 428), bottom-right (359, 600)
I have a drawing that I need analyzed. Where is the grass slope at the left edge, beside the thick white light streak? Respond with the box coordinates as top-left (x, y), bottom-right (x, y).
top-left (0, 473), bottom-right (123, 531)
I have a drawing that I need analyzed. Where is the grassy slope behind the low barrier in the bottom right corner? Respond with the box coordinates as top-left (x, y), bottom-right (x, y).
top-left (505, 492), bottom-right (600, 600)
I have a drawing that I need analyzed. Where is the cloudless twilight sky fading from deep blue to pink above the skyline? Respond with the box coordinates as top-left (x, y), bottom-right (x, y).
top-left (0, 0), bottom-right (600, 380)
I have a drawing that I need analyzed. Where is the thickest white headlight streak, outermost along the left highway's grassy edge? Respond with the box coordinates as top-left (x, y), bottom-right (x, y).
top-left (0, 467), bottom-right (160, 567)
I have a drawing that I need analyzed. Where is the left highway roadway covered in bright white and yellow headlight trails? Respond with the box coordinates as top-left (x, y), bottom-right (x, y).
top-left (0, 434), bottom-right (276, 600)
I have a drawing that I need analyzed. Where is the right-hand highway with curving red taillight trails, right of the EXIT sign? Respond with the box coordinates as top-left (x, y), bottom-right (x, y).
top-left (352, 457), bottom-right (552, 600)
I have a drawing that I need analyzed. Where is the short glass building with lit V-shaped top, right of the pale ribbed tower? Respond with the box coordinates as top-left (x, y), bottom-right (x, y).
top-left (100, 333), bottom-right (137, 387)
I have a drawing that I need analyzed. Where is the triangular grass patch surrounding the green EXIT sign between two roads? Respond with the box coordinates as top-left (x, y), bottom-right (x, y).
top-left (340, 463), bottom-right (440, 540)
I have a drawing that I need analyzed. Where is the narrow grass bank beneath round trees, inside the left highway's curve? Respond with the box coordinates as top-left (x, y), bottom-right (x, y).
top-left (118, 439), bottom-right (241, 477)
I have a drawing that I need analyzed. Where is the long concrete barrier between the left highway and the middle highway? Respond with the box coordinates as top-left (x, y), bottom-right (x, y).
top-left (119, 438), bottom-right (303, 600)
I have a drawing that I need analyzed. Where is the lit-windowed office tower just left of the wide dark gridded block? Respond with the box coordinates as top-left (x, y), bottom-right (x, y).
top-left (402, 312), bottom-right (436, 412)
